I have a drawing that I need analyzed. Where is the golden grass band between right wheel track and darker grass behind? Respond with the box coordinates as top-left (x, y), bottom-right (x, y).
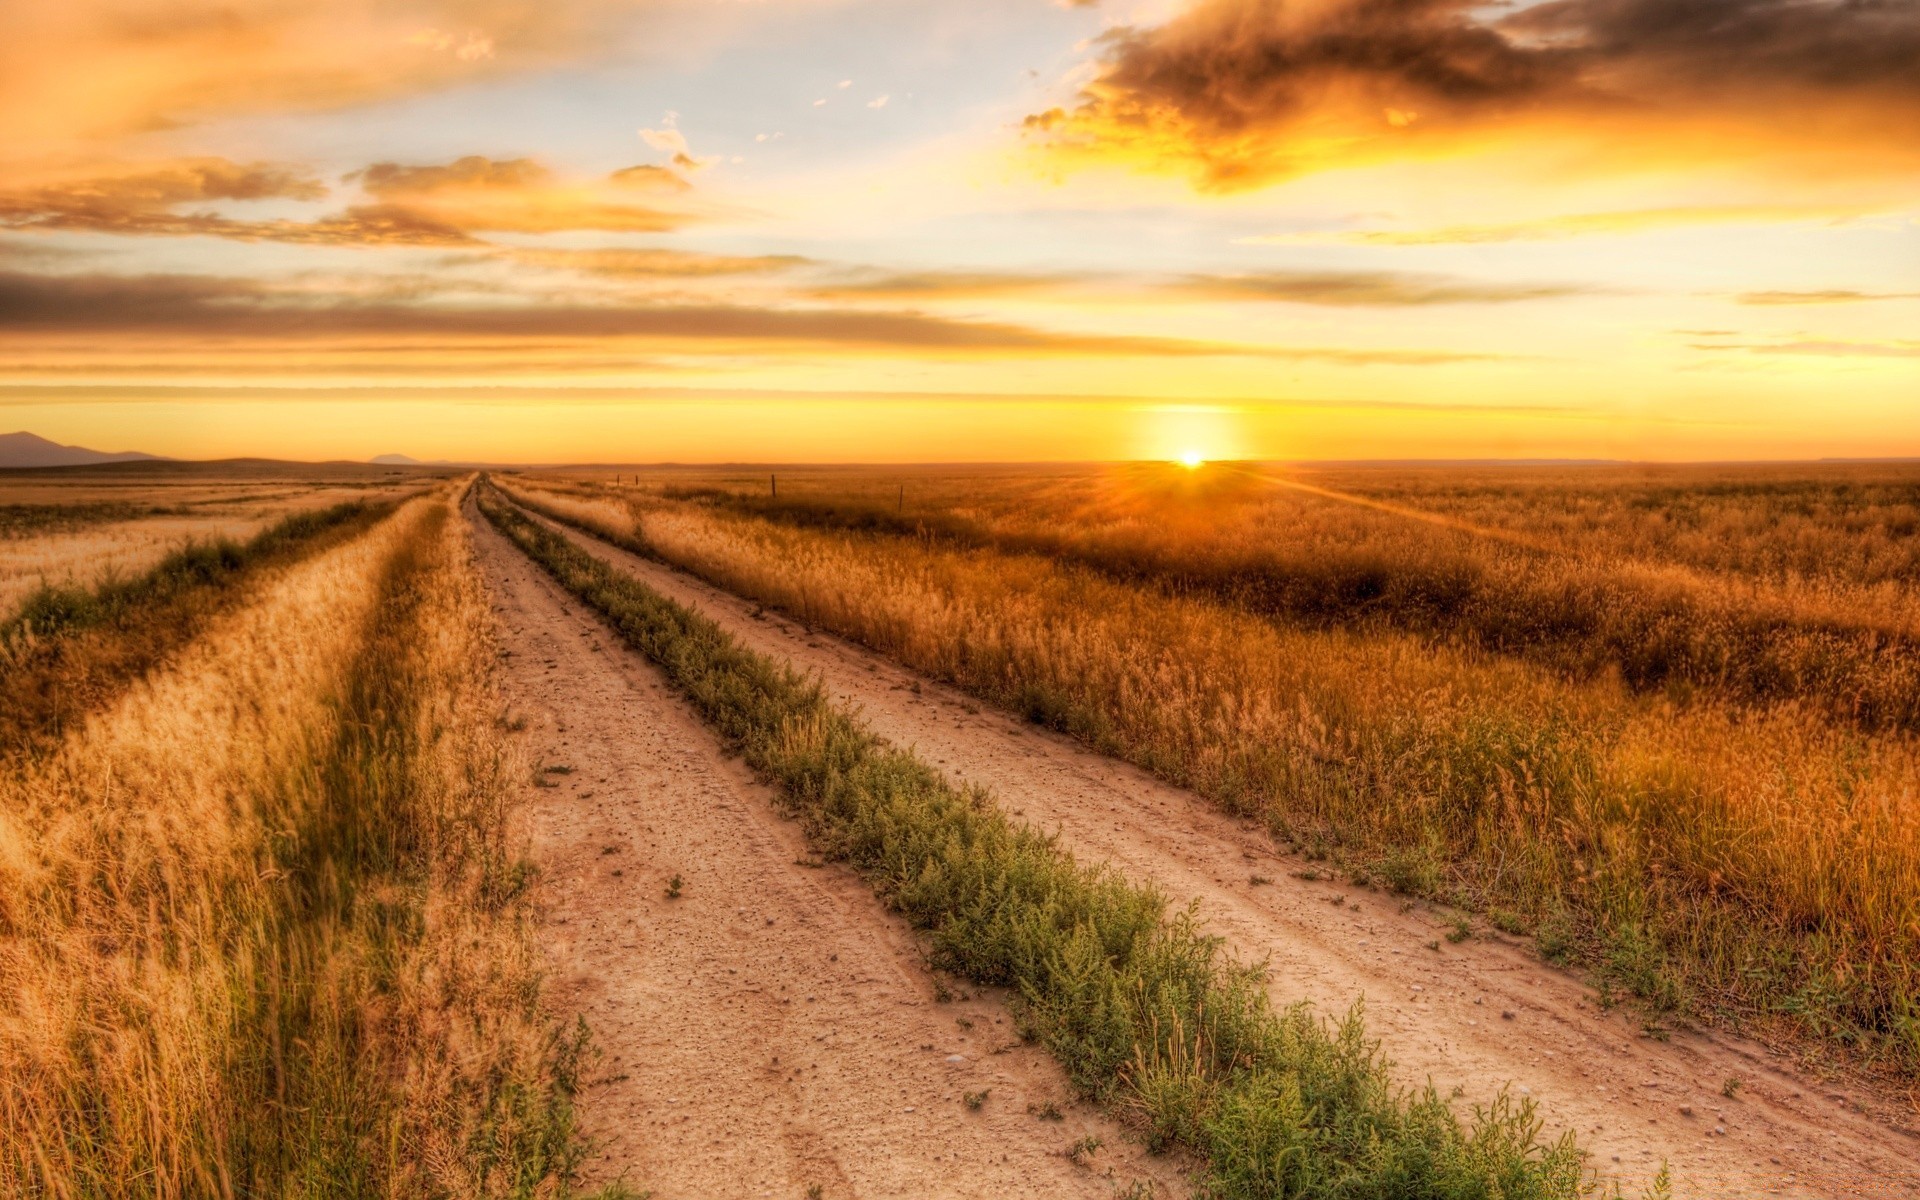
top-left (499, 472), bottom-right (1920, 1073)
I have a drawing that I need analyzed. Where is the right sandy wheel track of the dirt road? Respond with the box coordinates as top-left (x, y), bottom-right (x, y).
top-left (506, 503), bottom-right (1920, 1200)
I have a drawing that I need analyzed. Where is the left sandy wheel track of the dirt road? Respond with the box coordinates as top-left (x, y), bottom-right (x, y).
top-left (470, 499), bottom-right (1187, 1200)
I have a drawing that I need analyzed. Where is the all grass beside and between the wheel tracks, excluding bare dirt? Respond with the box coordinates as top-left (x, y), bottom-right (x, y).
top-left (0, 465), bottom-right (1920, 1200)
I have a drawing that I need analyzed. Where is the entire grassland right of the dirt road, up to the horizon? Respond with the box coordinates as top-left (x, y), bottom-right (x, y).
top-left (520, 467), bottom-right (1920, 1077)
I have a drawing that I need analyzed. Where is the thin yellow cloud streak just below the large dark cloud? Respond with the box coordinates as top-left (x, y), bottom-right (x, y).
top-left (1236, 204), bottom-right (1866, 246)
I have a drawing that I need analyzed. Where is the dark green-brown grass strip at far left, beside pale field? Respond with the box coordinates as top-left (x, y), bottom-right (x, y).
top-left (0, 501), bottom-right (397, 756)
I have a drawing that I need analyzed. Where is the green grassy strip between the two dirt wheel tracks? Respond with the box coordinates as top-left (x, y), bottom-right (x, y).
top-left (480, 481), bottom-right (1628, 1200)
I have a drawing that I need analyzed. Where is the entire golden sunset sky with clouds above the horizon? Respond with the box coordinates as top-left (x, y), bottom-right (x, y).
top-left (0, 0), bottom-right (1920, 463)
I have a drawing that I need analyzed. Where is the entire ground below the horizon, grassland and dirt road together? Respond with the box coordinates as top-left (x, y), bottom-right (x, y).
top-left (0, 465), bottom-right (1920, 1200)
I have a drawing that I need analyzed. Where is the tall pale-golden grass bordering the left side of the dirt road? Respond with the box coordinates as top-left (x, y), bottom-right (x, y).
top-left (0, 489), bottom-right (582, 1200)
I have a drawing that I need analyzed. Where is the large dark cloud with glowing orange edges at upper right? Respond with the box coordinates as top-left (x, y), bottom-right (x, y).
top-left (1027, 0), bottom-right (1920, 190)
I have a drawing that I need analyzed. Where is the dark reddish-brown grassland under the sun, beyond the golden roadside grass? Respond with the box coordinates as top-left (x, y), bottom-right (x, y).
top-left (648, 467), bottom-right (1920, 730)
